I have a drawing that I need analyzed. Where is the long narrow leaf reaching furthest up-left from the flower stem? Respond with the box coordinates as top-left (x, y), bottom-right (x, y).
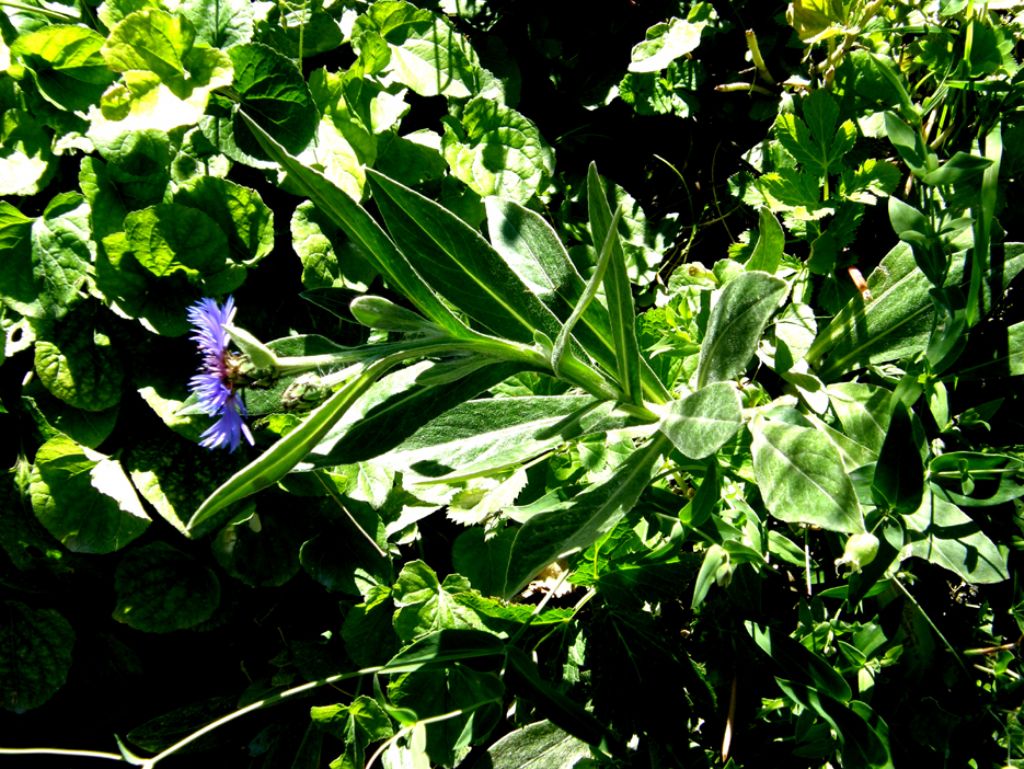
top-left (239, 111), bottom-right (466, 335)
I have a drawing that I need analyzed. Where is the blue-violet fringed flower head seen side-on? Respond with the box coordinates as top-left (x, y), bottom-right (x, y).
top-left (188, 297), bottom-right (254, 452)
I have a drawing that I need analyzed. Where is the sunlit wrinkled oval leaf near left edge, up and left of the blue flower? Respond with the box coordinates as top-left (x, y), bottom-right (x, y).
top-left (32, 193), bottom-right (95, 317)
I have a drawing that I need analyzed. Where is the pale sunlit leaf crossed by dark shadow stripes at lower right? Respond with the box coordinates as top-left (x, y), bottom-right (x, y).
top-left (903, 494), bottom-right (1010, 585)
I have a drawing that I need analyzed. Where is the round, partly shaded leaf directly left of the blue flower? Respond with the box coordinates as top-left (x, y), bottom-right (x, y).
top-left (35, 306), bottom-right (124, 412)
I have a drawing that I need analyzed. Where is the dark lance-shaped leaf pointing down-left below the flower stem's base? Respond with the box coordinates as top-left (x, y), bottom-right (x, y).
top-left (503, 434), bottom-right (669, 598)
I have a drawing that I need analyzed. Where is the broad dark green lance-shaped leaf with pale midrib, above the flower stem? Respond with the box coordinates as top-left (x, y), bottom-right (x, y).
top-left (368, 171), bottom-right (561, 344)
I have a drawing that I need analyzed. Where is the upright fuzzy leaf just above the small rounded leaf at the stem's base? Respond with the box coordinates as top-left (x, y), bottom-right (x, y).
top-left (697, 272), bottom-right (788, 388)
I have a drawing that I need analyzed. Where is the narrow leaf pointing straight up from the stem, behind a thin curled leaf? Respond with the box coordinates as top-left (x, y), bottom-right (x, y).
top-left (587, 163), bottom-right (642, 403)
